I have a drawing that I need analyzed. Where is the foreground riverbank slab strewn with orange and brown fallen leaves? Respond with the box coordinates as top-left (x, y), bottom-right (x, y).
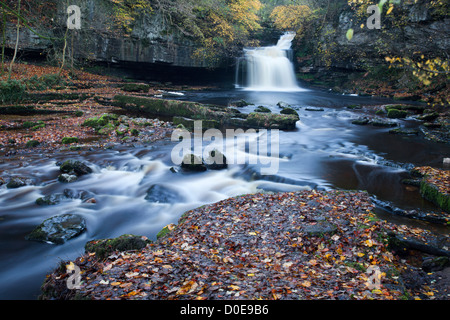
top-left (41, 191), bottom-right (450, 300)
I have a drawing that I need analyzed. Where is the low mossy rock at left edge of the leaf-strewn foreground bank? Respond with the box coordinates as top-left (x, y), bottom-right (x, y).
top-left (84, 234), bottom-right (152, 259)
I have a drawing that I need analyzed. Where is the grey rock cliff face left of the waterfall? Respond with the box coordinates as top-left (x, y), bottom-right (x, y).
top-left (7, 0), bottom-right (207, 67)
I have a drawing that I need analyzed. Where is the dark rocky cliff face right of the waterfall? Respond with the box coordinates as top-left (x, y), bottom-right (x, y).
top-left (304, 1), bottom-right (450, 70)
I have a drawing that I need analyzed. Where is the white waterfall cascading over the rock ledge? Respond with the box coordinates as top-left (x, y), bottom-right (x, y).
top-left (236, 32), bottom-right (304, 91)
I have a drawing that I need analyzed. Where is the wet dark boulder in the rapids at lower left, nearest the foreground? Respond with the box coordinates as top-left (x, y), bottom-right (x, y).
top-left (25, 214), bottom-right (86, 244)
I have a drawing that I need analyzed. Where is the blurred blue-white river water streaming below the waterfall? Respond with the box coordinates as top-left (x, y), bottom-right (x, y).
top-left (0, 91), bottom-right (450, 299)
